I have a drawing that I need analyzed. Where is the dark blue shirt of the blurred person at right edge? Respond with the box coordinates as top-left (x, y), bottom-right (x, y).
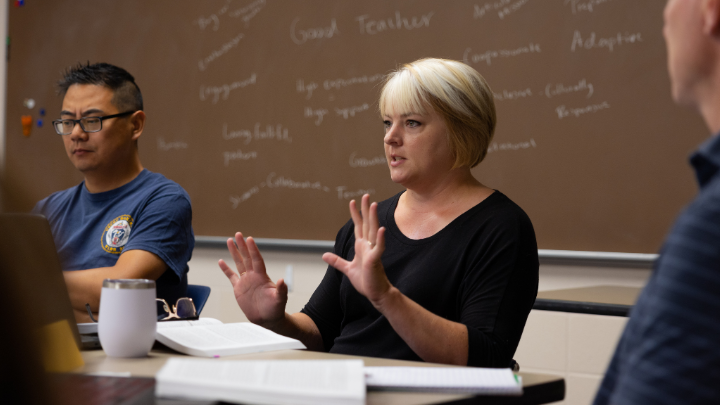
top-left (595, 134), bottom-right (720, 405)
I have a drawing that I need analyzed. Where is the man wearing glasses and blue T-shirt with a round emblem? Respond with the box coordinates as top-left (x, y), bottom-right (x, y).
top-left (33, 63), bottom-right (195, 322)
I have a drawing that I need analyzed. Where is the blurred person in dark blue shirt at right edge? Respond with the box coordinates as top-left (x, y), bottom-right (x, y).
top-left (595, 0), bottom-right (720, 405)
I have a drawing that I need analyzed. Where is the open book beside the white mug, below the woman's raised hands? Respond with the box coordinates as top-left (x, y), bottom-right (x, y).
top-left (155, 318), bottom-right (305, 357)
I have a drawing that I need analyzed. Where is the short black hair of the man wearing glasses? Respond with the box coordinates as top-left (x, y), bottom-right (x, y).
top-left (58, 62), bottom-right (143, 112)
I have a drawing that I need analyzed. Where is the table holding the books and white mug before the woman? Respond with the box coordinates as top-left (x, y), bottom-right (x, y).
top-left (76, 345), bottom-right (565, 405)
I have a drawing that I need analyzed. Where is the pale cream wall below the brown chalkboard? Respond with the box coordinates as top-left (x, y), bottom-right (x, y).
top-left (189, 248), bottom-right (650, 405)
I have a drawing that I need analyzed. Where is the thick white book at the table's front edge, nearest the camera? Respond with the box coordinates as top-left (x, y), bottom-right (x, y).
top-left (155, 358), bottom-right (365, 405)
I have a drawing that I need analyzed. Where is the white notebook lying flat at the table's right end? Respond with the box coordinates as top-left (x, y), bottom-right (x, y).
top-left (365, 367), bottom-right (522, 395)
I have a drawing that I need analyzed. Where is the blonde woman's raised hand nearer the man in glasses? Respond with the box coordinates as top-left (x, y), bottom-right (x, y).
top-left (218, 232), bottom-right (287, 328)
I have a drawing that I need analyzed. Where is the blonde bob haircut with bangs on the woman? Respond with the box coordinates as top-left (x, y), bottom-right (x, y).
top-left (380, 58), bottom-right (497, 169)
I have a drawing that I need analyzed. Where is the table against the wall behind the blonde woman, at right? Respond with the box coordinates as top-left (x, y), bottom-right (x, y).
top-left (533, 286), bottom-right (642, 316)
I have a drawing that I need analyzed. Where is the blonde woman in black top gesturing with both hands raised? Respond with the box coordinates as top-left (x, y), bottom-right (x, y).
top-left (220, 59), bottom-right (538, 367)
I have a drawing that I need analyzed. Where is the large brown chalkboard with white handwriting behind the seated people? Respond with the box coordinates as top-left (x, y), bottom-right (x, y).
top-left (4, 0), bottom-right (707, 253)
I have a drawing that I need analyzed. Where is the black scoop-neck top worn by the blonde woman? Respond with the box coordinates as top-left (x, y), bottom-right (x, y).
top-left (302, 191), bottom-right (539, 367)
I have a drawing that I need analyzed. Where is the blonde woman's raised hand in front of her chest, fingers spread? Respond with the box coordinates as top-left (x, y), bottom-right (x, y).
top-left (323, 194), bottom-right (392, 307)
